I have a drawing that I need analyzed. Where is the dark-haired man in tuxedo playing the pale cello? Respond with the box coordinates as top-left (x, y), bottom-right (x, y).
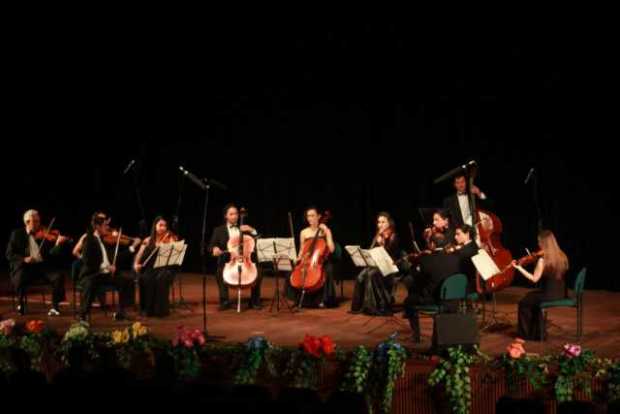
top-left (209, 204), bottom-right (262, 310)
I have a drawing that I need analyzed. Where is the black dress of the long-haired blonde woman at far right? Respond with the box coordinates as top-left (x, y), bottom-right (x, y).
top-left (518, 266), bottom-right (566, 341)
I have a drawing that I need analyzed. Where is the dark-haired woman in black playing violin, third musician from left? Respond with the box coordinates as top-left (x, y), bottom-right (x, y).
top-left (134, 216), bottom-right (178, 317)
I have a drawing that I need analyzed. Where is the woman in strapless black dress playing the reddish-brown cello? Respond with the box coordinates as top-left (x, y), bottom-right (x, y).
top-left (287, 206), bottom-right (338, 308)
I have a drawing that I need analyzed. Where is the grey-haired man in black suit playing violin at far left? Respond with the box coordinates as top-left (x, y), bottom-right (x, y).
top-left (6, 210), bottom-right (68, 316)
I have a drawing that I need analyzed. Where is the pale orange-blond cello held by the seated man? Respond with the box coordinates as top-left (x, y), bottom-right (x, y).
top-left (222, 208), bottom-right (258, 312)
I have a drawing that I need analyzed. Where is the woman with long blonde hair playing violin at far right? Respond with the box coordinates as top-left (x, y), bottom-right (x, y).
top-left (512, 230), bottom-right (568, 341)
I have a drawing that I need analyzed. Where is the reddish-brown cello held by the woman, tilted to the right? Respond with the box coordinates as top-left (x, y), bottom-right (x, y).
top-left (290, 211), bottom-right (331, 304)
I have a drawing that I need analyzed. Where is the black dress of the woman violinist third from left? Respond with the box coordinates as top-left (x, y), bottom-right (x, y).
top-left (138, 243), bottom-right (177, 317)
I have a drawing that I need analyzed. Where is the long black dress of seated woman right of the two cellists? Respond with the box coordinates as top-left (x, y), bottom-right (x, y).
top-left (351, 234), bottom-right (399, 315)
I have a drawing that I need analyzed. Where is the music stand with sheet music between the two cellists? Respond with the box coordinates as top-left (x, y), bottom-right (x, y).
top-left (256, 238), bottom-right (297, 313)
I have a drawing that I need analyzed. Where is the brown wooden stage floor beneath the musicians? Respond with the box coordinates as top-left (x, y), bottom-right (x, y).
top-left (0, 273), bottom-right (620, 357)
